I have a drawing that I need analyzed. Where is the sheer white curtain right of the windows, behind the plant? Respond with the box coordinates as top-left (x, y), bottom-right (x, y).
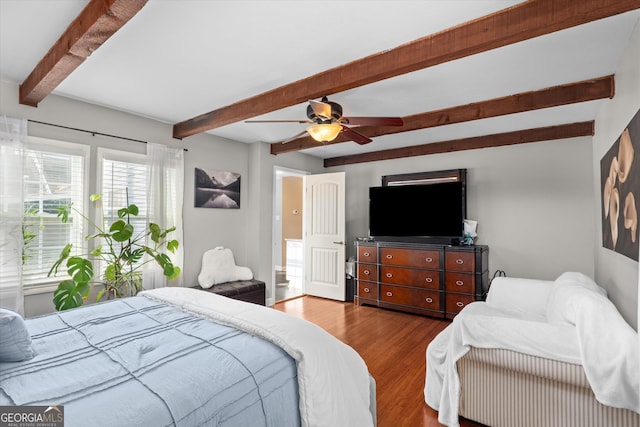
top-left (143, 143), bottom-right (184, 289)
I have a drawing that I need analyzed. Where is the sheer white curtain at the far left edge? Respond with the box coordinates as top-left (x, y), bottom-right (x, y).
top-left (0, 116), bottom-right (27, 315)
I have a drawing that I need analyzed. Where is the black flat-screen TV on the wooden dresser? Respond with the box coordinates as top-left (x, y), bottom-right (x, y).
top-left (369, 182), bottom-right (466, 239)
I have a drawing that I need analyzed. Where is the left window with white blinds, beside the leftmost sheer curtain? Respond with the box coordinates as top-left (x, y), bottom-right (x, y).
top-left (23, 137), bottom-right (89, 287)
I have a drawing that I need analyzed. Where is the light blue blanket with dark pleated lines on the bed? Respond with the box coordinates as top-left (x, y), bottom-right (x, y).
top-left (0, 297), bottom-right (300, 427)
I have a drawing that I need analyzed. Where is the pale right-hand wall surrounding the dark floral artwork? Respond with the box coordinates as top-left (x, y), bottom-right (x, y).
top-left (592, 19), bottom-right (640, 330)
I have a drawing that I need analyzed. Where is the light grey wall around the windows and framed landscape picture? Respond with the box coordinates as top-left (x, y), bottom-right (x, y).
top-left (0, 81), bottom-right (321, 316)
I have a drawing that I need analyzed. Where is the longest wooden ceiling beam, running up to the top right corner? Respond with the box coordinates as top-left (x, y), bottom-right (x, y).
top-left (173, 0), bottom-right (640, 139)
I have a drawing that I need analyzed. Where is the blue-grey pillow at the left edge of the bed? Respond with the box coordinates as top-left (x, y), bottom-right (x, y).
top-left (0, 308), bottom-right (35, 362)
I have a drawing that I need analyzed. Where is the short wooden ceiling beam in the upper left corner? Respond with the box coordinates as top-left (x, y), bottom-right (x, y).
top-left (19, 0), bottom-right (147, 107)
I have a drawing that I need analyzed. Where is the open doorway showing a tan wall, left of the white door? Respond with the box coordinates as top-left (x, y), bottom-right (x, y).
top-left (272, 166), bottom-right (309, 302)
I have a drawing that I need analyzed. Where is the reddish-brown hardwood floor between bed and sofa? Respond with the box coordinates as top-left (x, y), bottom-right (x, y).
top-left (274, 296), bottom-right (481, 427)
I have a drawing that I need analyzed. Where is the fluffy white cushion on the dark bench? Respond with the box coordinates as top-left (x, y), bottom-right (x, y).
top-left (198, 246), bottom-right (253, 289)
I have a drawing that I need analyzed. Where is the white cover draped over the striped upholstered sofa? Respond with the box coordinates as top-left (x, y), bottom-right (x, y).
top-left (424, 285), bottom-right (640, 427)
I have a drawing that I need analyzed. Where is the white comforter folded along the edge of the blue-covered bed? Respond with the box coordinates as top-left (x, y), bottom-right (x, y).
top-left (138, 288), bottom-right (374, 427)
